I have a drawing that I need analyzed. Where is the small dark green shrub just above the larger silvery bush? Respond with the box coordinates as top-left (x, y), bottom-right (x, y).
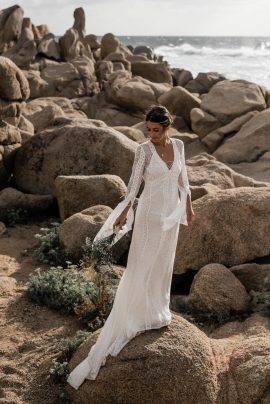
top-left (34, 222), bottom-right (71, 267)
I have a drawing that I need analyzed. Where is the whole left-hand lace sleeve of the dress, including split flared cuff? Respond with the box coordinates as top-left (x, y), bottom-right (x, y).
top-left (93, 145), bottom-right (145, 245)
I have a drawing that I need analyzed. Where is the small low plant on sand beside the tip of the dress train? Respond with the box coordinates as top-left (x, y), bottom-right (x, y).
top-left (49, 330), bottom-right (90, 383)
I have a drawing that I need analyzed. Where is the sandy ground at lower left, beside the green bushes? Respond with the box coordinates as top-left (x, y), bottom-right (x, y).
top-left (0, 223), bottom-right (82, 404)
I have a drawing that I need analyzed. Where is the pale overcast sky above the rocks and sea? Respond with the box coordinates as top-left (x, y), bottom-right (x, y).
top-left (0, 0), bottom-right (270, 36)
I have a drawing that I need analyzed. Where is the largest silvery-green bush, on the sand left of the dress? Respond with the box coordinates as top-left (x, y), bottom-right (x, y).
top-left (26, 267), bottom-right (98, 312)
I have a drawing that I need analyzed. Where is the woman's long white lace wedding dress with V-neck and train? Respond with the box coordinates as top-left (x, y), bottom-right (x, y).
top-left (67, 138), bottom-right (190, 389)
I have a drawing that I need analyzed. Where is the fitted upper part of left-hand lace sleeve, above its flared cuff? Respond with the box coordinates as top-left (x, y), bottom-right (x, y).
top-left (124, 145), bottom-right (145, 206)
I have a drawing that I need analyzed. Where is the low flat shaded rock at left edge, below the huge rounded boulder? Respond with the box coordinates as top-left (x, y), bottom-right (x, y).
top-left (0, 188), bottom-right (53, 217)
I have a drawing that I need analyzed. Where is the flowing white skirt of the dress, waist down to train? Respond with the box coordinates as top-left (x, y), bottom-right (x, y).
top-left (67, 190), bottom-right (179, 389)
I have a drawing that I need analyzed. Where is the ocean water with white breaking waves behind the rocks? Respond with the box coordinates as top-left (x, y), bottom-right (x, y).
top-left (118, 36), bottom-right (270, 89)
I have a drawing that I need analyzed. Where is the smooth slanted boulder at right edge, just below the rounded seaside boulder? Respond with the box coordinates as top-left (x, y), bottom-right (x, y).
top-left (214, 108), bottom-right (270, 165)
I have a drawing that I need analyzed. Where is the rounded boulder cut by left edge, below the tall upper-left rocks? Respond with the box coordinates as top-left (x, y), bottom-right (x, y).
top-left (0, 56), bottom-right (30, 101)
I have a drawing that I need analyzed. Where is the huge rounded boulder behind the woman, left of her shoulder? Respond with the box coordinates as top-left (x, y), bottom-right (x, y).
top-left (15, 118), bottom-right (137, 194)
